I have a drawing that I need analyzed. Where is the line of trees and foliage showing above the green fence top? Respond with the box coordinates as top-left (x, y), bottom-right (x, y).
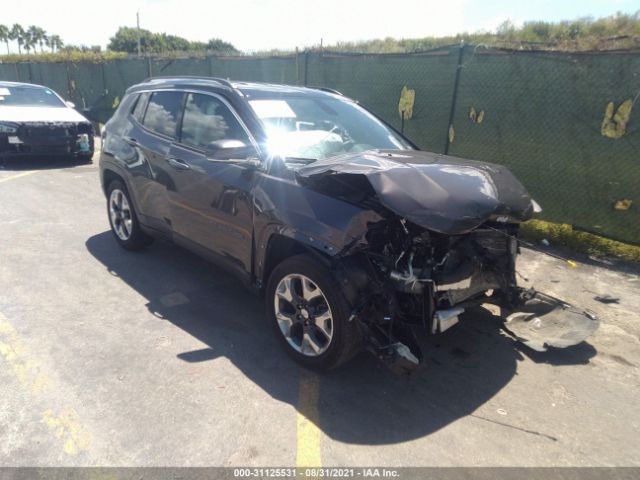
top-left (0, 10), bottom-right (640, 61)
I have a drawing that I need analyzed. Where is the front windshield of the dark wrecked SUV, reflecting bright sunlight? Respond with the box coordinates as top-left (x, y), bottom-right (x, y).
top-left (249, 95), bottom-right (412, 160)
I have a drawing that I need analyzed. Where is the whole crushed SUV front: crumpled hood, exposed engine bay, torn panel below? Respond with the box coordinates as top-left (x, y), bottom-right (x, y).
top-left (299, 151), bottom-right (598, 372)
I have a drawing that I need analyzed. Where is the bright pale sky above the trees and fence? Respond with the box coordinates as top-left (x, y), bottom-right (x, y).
top-left (0, 0), bottom-right (640, 52)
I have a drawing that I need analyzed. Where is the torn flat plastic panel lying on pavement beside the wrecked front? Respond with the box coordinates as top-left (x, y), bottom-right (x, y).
top-left (504, 290), bottom-right (600, 352)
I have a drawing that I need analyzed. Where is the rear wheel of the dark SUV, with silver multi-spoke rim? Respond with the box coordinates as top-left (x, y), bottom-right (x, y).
top-left (107, 180), bottom-right (153, 250)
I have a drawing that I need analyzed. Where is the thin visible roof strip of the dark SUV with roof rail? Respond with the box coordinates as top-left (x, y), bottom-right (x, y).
top-left (130, 76), bottom-right (342, 98)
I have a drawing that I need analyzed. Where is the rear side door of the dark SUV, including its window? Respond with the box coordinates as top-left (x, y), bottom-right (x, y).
top-left (133, 91), bottom-right (184, 230)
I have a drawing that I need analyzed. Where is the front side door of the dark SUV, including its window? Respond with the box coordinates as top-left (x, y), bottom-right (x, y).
top-left (170, 93), bottom-right (260, 274)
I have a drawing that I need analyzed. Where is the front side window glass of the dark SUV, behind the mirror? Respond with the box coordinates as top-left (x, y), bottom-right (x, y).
top-left (180, 93), bottom-right (250, 150)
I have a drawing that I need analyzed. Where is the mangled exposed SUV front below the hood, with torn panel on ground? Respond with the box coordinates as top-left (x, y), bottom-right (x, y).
top-left (337, 216), bottom-right (598, 373)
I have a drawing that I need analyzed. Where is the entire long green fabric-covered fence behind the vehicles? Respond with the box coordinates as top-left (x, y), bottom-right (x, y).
top-left (0, 45), bottom-right (640, 244)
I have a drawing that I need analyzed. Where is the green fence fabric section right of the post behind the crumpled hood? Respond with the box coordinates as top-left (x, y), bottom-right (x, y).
top-left (449, 47), bottom-right (640, 243)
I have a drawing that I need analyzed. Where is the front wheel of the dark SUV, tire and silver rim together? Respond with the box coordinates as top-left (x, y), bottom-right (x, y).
top-left (265, 255), bottom-right (361, 371)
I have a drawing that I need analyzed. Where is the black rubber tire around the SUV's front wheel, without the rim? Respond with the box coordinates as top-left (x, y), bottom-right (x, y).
top-left (265, 255), bottom-right (361, 371)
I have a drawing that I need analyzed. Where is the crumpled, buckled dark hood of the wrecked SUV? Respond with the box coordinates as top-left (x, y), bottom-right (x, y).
top-left (296, 150), bottom-right (533, 235)
